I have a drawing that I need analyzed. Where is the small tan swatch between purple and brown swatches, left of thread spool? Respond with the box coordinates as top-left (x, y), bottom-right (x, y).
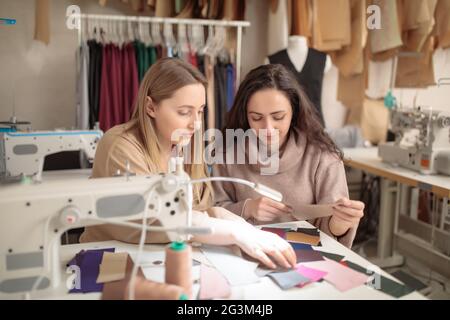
top-left (97, 252), bottom-right (128, 283)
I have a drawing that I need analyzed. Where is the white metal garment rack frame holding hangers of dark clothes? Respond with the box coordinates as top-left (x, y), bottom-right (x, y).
top-left (78, 14), bottom-right (250, 84)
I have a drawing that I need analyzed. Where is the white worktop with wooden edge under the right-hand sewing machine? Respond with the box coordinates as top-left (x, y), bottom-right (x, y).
top-left (343, 147), bottom-right (450, 197)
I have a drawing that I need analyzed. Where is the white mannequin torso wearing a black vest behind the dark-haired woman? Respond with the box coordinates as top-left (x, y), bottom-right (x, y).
top-left (266, 36), bottom-right (331, 125)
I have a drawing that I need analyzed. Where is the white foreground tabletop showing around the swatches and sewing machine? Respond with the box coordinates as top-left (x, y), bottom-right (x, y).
top-left (15, 222), bottom-right (426, 300)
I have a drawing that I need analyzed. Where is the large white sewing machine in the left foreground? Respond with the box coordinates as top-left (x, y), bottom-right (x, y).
top-left (0, 174), bottom-right (192, 297)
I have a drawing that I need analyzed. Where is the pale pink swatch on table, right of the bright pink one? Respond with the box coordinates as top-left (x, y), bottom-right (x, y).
top-left (305, 260), bottom-right (370, 291)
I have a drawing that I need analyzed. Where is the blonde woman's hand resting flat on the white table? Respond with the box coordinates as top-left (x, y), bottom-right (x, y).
top-left (234, 226), bottom-right (297, 269)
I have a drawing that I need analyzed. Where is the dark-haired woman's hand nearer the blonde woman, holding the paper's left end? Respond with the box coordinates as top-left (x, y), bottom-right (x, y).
top-left (243, 197), bottom-right (293, 222)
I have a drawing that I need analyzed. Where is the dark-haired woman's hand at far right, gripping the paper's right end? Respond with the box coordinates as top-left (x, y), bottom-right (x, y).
top-left (330, 198), bottom-right (364, 236)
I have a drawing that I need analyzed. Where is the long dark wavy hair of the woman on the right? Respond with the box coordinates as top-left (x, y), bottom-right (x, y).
top-left (223, 64), bottom-right (343, 160)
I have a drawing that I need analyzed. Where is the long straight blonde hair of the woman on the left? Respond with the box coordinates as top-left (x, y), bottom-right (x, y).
top-left (128, 58), bottom-right (212, 209)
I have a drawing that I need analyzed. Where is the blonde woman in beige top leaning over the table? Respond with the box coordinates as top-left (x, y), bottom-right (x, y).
top-left (80, 58), bottom-right (296, 268)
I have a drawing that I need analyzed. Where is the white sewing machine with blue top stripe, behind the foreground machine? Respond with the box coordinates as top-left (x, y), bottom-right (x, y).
top-left (0, 130), bottom-right (103, 180)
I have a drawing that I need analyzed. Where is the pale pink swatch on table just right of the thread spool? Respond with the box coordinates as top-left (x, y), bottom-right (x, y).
top-left (199, 264), bottom-right (231, 300)
